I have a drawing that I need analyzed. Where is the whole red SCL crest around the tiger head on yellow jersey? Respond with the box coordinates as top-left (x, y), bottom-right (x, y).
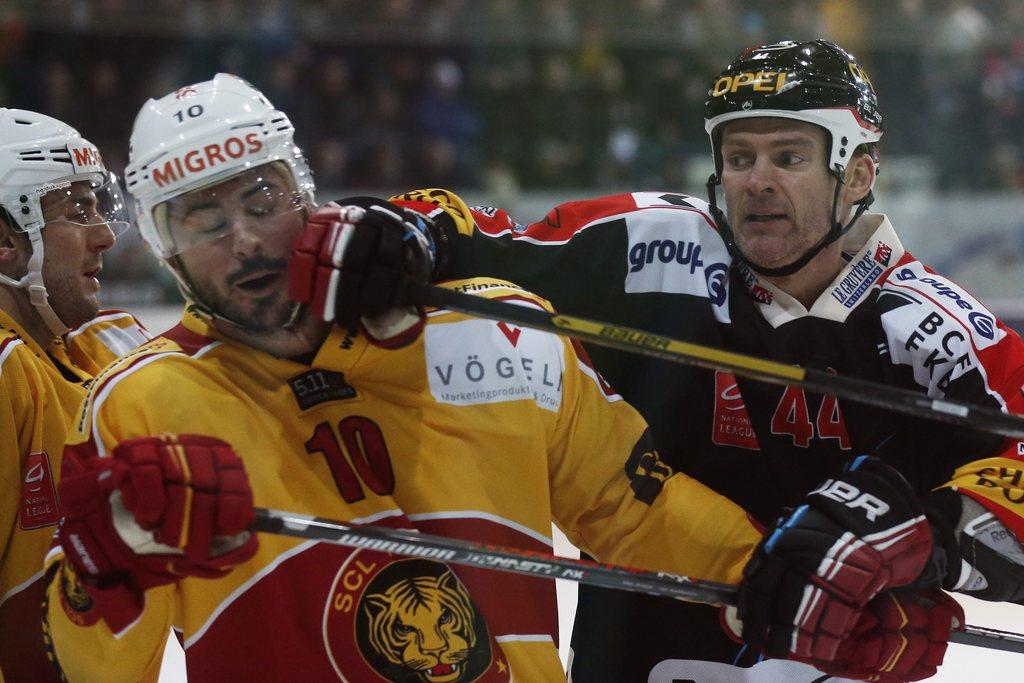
top-left (324, 550), bottom-right (511, 683)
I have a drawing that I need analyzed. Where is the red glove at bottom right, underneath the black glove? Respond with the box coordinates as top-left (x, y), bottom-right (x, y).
top-left (802, 590), bottom-right (966, 683)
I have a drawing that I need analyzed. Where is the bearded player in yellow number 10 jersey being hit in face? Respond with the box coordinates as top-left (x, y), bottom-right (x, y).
top-left (44, 75), bottom-right (942, 683)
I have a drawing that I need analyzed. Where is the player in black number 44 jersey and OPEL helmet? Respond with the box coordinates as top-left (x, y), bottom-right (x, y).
top-left (325, 40), bottom-right (1024, 683)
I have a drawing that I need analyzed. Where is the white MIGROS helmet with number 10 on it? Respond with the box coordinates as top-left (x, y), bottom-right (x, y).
top-left (125, 74), bottom-right (315, 259)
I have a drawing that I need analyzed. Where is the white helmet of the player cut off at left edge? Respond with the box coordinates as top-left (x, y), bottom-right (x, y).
top-left (0, 109), bottom-right (130, 336)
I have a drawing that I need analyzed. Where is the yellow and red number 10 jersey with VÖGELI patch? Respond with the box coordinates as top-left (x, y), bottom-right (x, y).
top-left (47, 279), bottom-right (760, 683)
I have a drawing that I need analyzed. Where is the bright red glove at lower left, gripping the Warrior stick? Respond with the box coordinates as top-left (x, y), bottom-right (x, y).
top-left (60, 434), bottom-right (258, 592)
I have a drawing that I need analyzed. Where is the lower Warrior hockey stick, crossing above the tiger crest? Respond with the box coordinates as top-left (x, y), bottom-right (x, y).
top-left (253, 508), bottom-right (1024, 653)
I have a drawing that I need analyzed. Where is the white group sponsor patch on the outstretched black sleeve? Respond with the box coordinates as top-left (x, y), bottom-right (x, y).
top-left (625, 201), bottom-right (731, 323)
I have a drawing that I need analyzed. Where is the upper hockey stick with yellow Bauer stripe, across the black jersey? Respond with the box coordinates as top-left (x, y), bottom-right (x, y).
top-left (410, 284), bottom-right (1024, 438)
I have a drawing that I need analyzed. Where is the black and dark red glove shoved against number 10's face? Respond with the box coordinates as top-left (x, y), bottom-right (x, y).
top-left (289, 198), bottom-right (446, 348)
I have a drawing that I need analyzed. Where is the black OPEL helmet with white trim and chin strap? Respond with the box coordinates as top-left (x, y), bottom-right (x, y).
top-left (705, 40), bottom-right (883, 275)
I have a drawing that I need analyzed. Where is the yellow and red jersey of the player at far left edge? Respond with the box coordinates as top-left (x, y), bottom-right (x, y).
top-left (0, 310), bottom-right (148, 681)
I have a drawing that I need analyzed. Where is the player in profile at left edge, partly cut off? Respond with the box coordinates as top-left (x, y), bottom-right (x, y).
top-left (0, 109), bottom-right (146, 683)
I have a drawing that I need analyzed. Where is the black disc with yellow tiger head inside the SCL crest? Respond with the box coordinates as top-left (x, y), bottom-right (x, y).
top-left (356, 560), bottom-right (492, 683)
